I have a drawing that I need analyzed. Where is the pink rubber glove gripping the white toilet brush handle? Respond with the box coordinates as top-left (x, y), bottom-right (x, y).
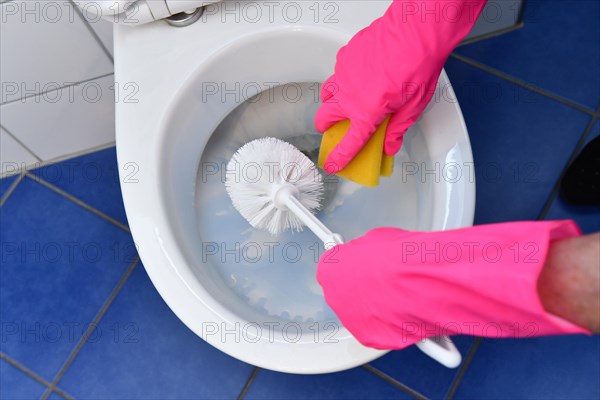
top-left (317, 221), bottom-right (590, 349)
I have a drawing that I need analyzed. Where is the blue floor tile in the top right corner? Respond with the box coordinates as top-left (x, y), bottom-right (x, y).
top-left (456, 0), bottom-right (600, 110)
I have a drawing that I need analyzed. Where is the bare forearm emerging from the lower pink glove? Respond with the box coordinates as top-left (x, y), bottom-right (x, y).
top-left (538, 233), bottom-right (600, 332)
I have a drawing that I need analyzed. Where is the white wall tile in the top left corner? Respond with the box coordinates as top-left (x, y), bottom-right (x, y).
top-left (0, 0), bottom-right (113, 103)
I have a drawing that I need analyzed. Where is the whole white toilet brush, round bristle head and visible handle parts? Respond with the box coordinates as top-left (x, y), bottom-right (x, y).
top-left (225, 138), bottom-right (461, 368)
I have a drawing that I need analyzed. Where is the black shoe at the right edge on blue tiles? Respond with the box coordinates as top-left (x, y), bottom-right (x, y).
top-left (560, 136), bottom-right (600, 205)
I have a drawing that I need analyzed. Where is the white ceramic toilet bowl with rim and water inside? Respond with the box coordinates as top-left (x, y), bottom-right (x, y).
top-left (115, 1), bottom-right (474, 373)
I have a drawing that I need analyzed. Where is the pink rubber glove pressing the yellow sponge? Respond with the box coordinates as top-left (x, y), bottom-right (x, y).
top-left (315, 0), bottom-right (486, 173)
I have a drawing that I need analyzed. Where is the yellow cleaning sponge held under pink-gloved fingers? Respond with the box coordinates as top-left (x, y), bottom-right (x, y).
top-left (319, 117), bottom-right (394, 187)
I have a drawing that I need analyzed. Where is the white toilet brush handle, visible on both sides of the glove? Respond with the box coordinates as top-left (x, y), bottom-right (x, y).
top-left (274, 185), bottom-right (462, 368)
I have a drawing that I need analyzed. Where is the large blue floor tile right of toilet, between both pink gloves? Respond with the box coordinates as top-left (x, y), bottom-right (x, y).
top-left (446, 59), bottom-right (591, 224)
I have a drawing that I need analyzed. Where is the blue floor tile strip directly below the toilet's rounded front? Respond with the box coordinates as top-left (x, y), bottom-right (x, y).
top-left (244, 367), bottom-right (415, 400)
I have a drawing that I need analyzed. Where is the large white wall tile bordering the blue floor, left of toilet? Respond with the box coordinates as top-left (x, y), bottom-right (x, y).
top-left (0, 75), bottom-right (116, 161)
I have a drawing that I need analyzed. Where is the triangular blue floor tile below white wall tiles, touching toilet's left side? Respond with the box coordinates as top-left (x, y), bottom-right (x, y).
top-left (31, 147), bottom-right (127, 225)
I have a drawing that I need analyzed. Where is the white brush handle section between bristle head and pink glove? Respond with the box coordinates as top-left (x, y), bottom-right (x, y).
top-left (274, 185), bottom-right (344, 250)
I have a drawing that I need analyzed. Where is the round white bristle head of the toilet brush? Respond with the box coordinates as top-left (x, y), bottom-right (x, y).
top-left (225, 137), bottom-right (323, 235)
